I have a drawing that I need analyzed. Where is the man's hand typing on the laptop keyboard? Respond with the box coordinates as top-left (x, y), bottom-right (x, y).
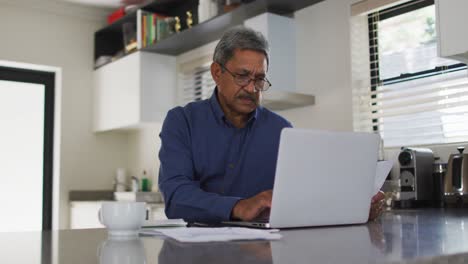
top-left (231, 190), bottom-right (273, 221)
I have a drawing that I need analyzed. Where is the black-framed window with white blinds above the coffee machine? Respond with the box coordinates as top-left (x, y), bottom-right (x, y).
top-left (353, 0), bottom-right (468, 146)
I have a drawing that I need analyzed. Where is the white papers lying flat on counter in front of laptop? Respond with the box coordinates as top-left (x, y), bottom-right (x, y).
top-left (140, 227), bottom-right (282, 242)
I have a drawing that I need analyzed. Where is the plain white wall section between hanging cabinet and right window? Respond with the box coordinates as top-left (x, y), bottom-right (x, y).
top-left (280, 0), bottom-right (353, 131)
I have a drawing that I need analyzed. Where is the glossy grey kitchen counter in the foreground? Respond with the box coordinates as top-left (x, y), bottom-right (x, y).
top-left (0, 209), bottom-right (468, 264)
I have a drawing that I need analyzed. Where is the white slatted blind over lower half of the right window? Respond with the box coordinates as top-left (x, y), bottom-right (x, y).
top-left (355, 72), bottom-right (468, 146)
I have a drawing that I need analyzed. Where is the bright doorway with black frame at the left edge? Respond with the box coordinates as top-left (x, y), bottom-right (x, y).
top-left (0, 67), bottom-right (55, 232)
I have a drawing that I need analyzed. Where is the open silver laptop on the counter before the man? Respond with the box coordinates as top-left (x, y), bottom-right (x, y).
top-left (223, 128), bottom-right (380, 228)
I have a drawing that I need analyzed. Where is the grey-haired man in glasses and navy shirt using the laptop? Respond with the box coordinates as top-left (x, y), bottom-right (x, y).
top-left (159, 27), bottom-right (382, 222)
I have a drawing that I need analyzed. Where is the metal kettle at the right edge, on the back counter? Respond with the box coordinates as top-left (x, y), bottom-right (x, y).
top-left (444, 147), bottom-right (468, 196)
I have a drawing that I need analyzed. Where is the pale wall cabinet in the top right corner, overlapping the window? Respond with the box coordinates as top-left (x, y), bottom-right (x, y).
top-left (435, 0), bottom-right (468, 63)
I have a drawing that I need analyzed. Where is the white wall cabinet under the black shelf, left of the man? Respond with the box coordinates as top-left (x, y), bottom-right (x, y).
top-left (93, 51), bottom-right (176, 132)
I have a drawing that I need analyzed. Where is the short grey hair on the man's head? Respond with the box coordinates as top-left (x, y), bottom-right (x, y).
top-left (213, 26), bottom-right (270, 65)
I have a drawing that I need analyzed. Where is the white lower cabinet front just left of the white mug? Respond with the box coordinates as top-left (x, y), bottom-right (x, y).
top-left (70, 201), bottom-right (104, 229)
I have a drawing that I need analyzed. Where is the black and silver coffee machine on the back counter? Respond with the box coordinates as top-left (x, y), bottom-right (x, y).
top-left (398, 147), bottom-right (434, 203)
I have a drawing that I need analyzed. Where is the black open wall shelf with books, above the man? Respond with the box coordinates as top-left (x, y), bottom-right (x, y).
top-left (94, 0), bottom-right (324, 66)
